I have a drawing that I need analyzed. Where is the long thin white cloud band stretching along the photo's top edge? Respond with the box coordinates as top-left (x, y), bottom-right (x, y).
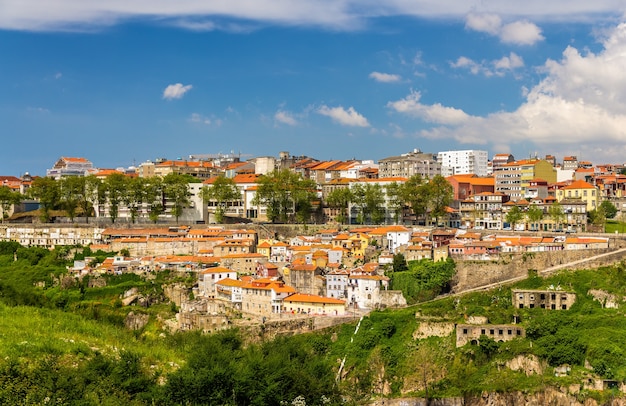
top-left (0, 0), bottom-right (626, 35)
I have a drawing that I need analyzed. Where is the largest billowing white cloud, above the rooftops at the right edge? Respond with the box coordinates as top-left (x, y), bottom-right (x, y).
top-left (388, 23), bottom-right (626, 162)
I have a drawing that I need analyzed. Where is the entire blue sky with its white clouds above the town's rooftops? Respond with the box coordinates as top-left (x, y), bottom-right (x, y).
top-left (0, 0), bottom-right (626, 176)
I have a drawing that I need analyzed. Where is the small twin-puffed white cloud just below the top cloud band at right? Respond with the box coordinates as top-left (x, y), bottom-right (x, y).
top-left (465, 13), bottom-right (544, 45)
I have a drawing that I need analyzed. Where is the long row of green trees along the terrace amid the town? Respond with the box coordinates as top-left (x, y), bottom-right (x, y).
top-left (0, 170), bottom-right (452, 224)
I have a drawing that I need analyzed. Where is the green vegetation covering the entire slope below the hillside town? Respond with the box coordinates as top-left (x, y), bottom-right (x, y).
top-left (0, 243), bottom-right (626, 405)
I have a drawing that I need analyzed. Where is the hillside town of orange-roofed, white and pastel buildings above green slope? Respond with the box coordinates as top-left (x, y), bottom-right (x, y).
top-left (0, 149), bottom-right (626, 331)
